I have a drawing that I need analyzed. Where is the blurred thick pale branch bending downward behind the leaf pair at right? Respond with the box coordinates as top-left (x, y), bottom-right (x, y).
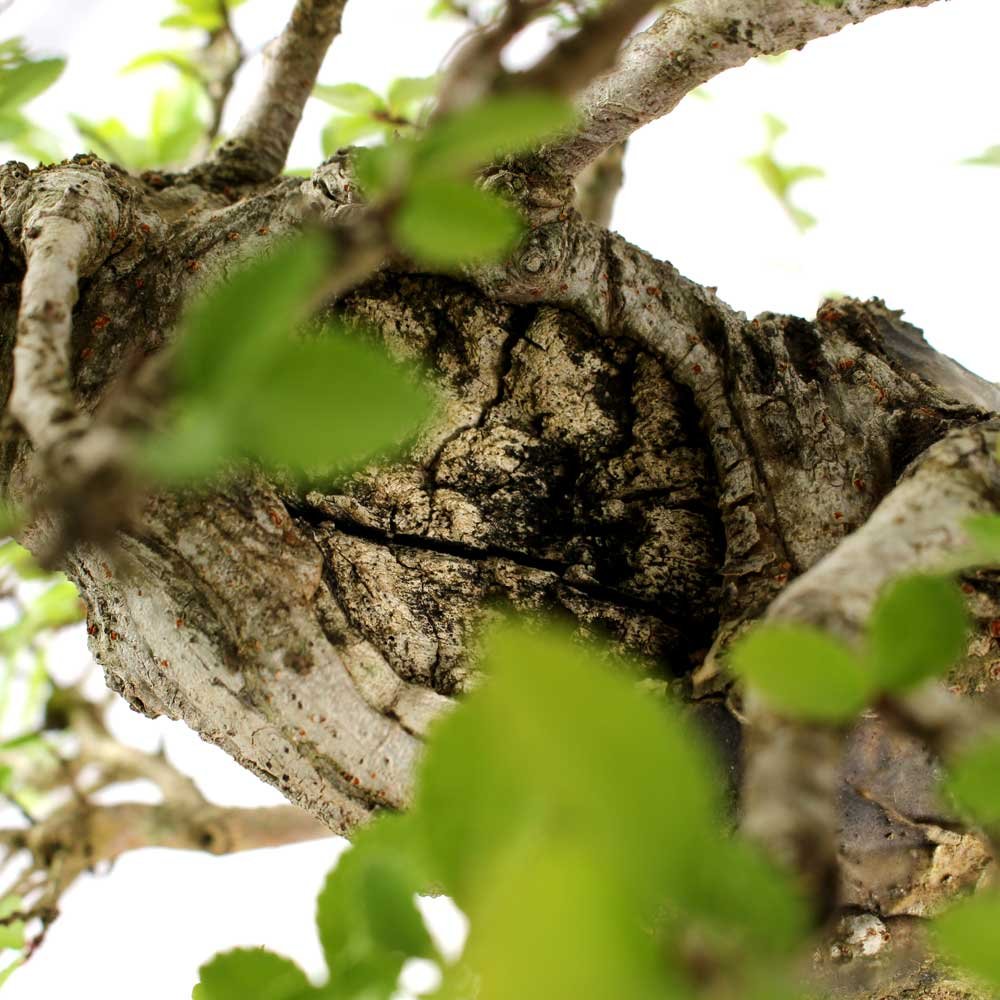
top-left (743, 420), bottom-right (1000, 911)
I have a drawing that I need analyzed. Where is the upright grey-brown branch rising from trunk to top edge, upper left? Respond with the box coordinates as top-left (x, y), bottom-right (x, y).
top-left (209, 0), bottom-right (347, 183)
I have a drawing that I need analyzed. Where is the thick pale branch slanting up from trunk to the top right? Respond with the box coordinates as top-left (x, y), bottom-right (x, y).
top-left (544, 0), bottom-right (934, 175)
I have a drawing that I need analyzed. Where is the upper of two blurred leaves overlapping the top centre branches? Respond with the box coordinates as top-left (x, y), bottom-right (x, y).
top-left (417, 93), bottom-right (576, 178)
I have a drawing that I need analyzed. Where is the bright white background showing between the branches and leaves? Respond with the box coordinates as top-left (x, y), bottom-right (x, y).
top-left (0, 0), bottom-right (1000, 1000)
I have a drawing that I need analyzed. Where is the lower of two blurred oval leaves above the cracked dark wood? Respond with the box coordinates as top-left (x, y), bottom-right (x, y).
top-left (393, 178), bottom-right (521, 267)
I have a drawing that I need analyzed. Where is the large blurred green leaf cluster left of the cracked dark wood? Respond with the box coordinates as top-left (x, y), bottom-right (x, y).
top-left (145, 237), bottom-right (430, 480)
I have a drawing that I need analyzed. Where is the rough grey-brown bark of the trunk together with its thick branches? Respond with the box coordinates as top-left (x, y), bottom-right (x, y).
top-left (0, 0), bottom-right (1000, 1000)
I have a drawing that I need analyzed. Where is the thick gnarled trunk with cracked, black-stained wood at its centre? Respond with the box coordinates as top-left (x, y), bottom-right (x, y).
top-left (0, 164), bottom-right (1000, 996)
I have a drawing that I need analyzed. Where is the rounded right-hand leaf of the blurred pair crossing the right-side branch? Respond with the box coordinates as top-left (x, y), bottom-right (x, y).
top-left (868, 576), bottom-right (968, 691)
